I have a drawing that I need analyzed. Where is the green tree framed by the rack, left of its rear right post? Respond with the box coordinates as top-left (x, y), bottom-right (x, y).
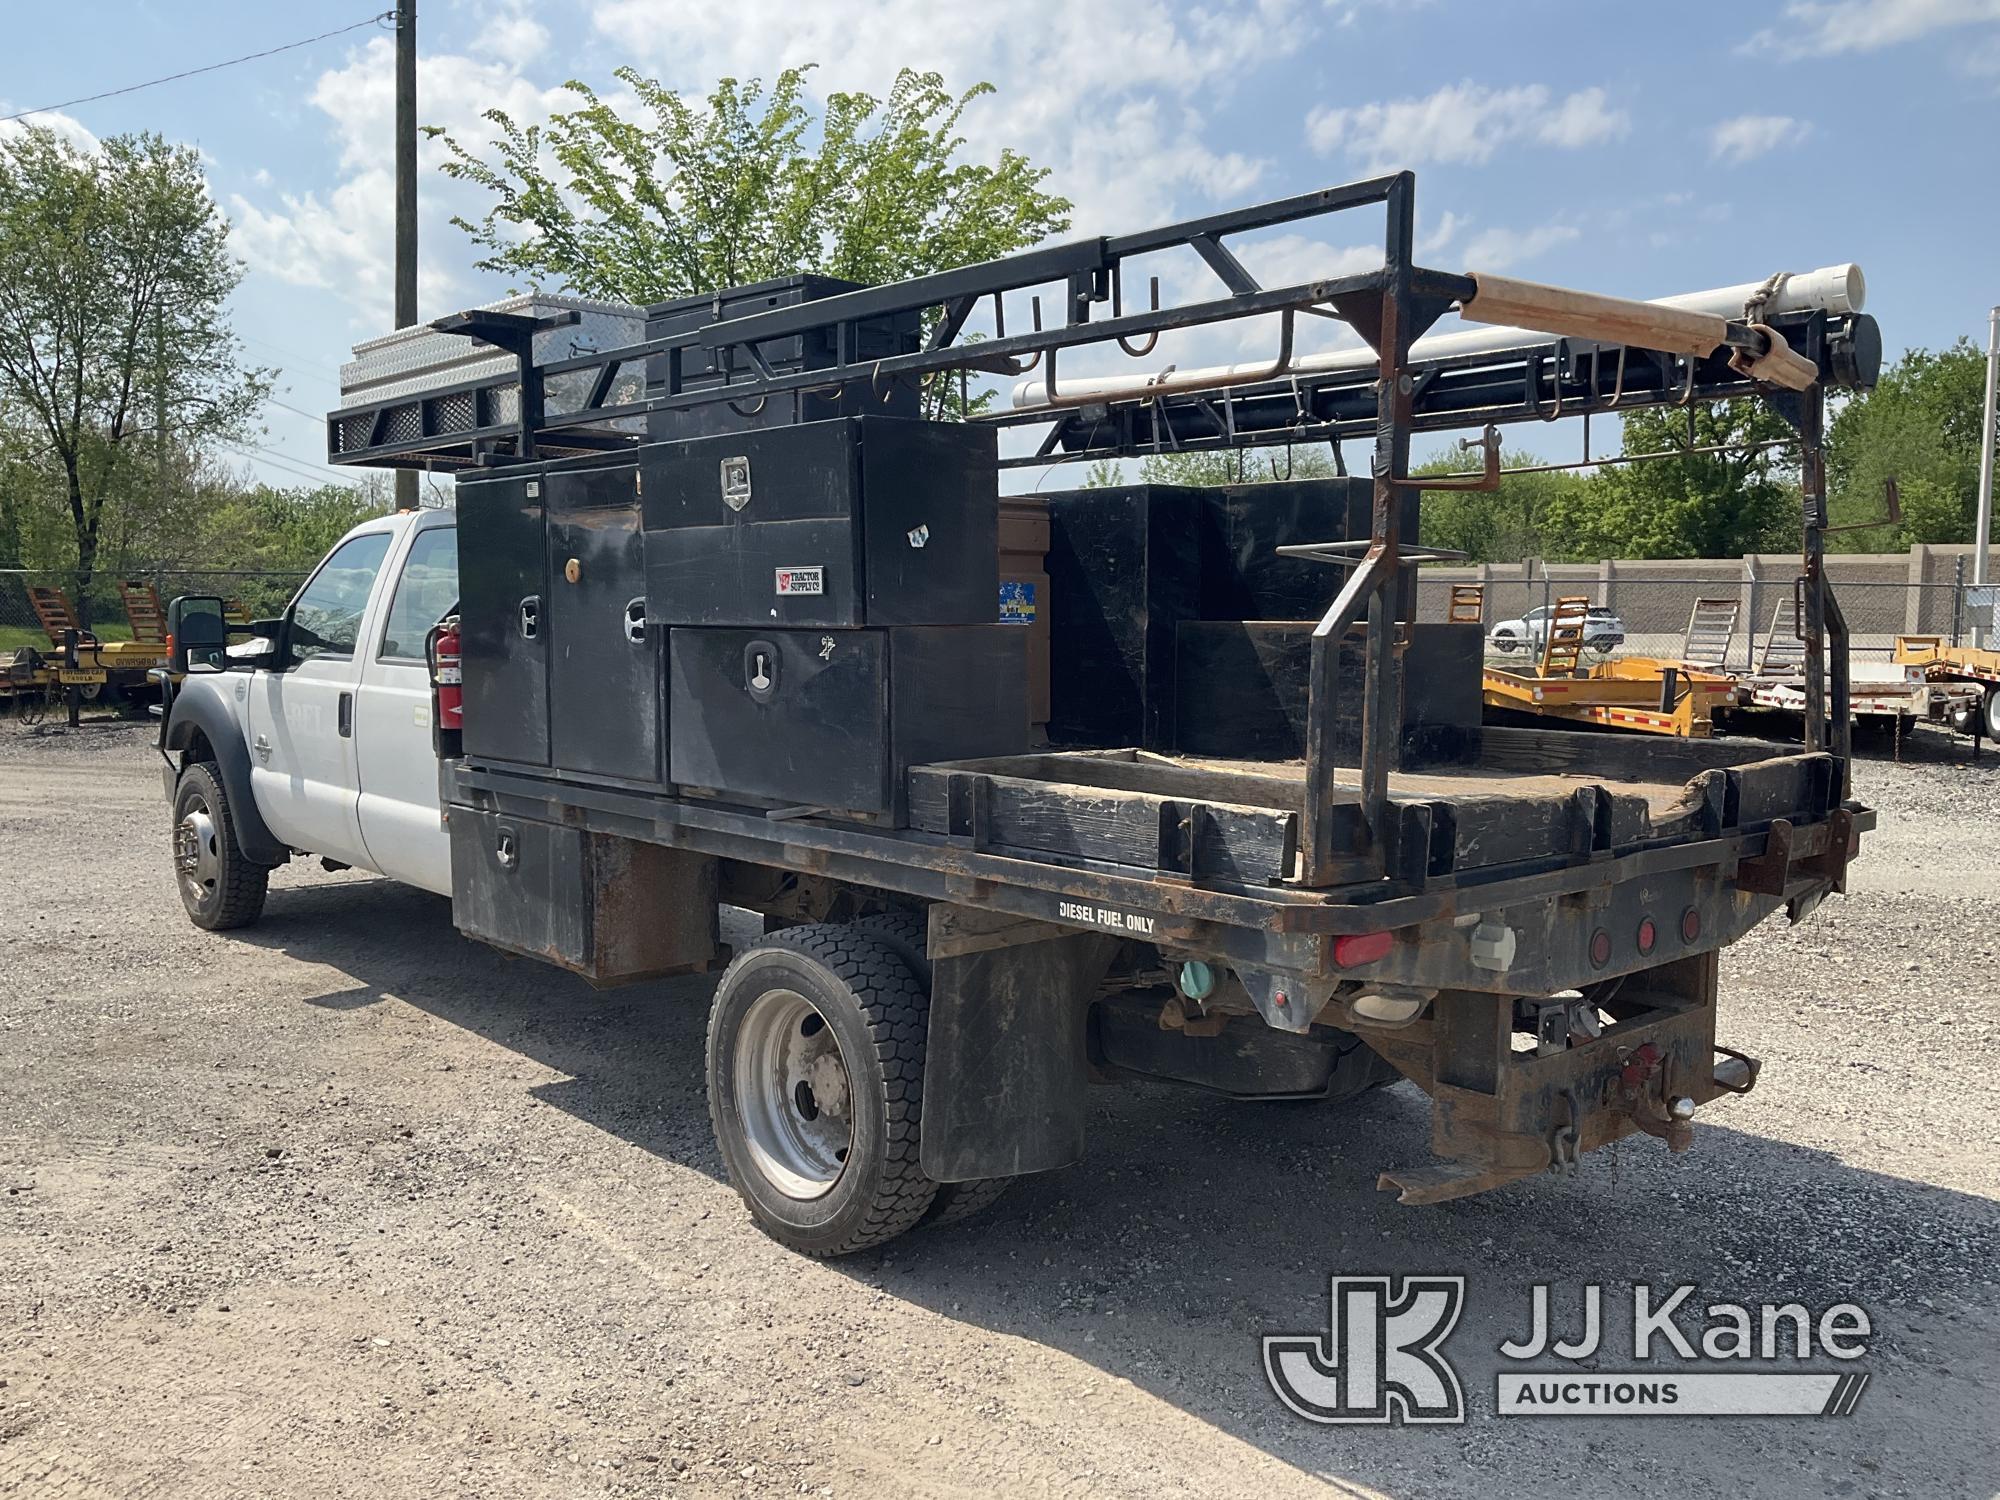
top-left (1542, 398), bottom-right (1798, 560)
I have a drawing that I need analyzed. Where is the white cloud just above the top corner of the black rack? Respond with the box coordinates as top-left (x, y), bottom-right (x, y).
top-left (1306, 80), bottom-right (1632, 172)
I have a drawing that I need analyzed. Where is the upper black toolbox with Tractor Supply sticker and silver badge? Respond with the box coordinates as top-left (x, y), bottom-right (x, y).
top-left (640, 418), bottom-right (1000, 628)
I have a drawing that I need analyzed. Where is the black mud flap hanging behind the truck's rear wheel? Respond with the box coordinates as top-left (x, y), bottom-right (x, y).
top-left (922, 902), bottom-right (1118, 1182)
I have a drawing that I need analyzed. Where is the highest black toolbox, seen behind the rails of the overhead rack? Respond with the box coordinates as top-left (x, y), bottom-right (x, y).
top-left (646, 276), bottom-right (922, 438)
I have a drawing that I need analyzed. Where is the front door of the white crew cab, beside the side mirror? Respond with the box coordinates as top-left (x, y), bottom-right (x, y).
top-left (248, 530), bottom-right (396, 864)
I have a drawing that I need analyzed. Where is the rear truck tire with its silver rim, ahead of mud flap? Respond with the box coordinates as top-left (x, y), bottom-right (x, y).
top-left (708, 922), bottom-right (938, 1256)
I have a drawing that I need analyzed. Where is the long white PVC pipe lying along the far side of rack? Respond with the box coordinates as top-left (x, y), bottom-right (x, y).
top-left (1014, 264), bottom-right (1868, 410)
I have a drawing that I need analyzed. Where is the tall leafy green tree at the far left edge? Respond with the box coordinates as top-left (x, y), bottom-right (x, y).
top-left (0, 128), bottom-right (268, 624)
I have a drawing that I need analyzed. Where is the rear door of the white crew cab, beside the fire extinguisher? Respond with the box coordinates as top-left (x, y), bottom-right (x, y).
top-left (354, 524), bottom-right (458, 896)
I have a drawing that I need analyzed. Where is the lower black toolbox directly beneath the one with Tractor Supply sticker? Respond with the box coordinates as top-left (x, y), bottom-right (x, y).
top-left (666, 624), bottom-right (1028, 826)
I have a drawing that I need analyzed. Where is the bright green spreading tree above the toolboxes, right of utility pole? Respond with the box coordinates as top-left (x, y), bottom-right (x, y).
top-left (430, 68), bottom-right (1070, 418)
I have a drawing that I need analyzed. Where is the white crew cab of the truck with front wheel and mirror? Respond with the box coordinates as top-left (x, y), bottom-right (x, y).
top-left (160, 510), bottom-right (458, 930)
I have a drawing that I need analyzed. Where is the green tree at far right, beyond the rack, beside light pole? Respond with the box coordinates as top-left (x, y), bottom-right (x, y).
top-left (1826, 338), bottom-right (1986, 552)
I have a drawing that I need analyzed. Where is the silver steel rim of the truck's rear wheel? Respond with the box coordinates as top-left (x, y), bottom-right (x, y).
top-left (736, 990), bottom-right (854, 1200)
